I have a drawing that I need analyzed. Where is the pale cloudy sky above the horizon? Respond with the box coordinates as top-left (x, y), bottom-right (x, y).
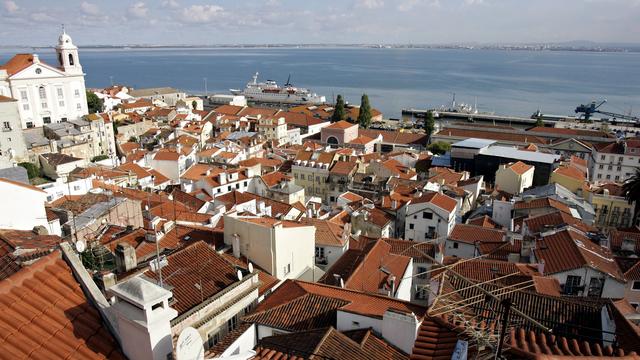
top-left (0, 0), bottom-right (640, 46)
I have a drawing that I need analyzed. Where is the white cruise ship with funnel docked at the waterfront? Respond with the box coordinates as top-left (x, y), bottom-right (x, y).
top-left (229, 73), bottom-right (326, 105)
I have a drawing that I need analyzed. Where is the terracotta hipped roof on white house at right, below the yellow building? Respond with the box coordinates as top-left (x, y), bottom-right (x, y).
top-left (534, 229), bottom-right (625, 282)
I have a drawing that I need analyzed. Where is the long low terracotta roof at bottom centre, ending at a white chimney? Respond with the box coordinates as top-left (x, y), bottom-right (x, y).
top-left (244, 280), bottom-right (426, 331)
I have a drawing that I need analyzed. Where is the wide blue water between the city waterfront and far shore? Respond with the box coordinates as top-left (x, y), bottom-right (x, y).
top-left (0, 48), bottom-right (640, 117)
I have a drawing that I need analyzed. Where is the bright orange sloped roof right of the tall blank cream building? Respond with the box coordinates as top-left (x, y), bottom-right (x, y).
top-left (319, 239), bottom-right (411, 296)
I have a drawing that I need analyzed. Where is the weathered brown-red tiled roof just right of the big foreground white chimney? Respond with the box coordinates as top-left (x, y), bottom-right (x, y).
top-left (144, 241), bottom-right (239, 315)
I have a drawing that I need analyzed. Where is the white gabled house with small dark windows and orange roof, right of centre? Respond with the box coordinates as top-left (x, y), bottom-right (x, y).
top-left (404, 192), bottom-right (458, 241)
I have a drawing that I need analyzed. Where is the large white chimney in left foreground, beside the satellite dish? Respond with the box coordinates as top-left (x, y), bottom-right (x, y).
top-left (109, 277), bottom-right (178, 360)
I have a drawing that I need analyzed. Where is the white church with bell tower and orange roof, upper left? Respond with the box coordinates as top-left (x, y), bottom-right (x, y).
top-left (0, 30), bottom-right (88, 129)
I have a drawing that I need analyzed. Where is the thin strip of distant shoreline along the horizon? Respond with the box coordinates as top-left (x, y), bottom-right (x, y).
top-left (0, 44), bottom-right (640, 53)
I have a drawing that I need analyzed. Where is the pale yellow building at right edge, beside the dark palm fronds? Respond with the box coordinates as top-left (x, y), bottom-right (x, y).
top-left (589, 183), bottom-right (635, 228)
